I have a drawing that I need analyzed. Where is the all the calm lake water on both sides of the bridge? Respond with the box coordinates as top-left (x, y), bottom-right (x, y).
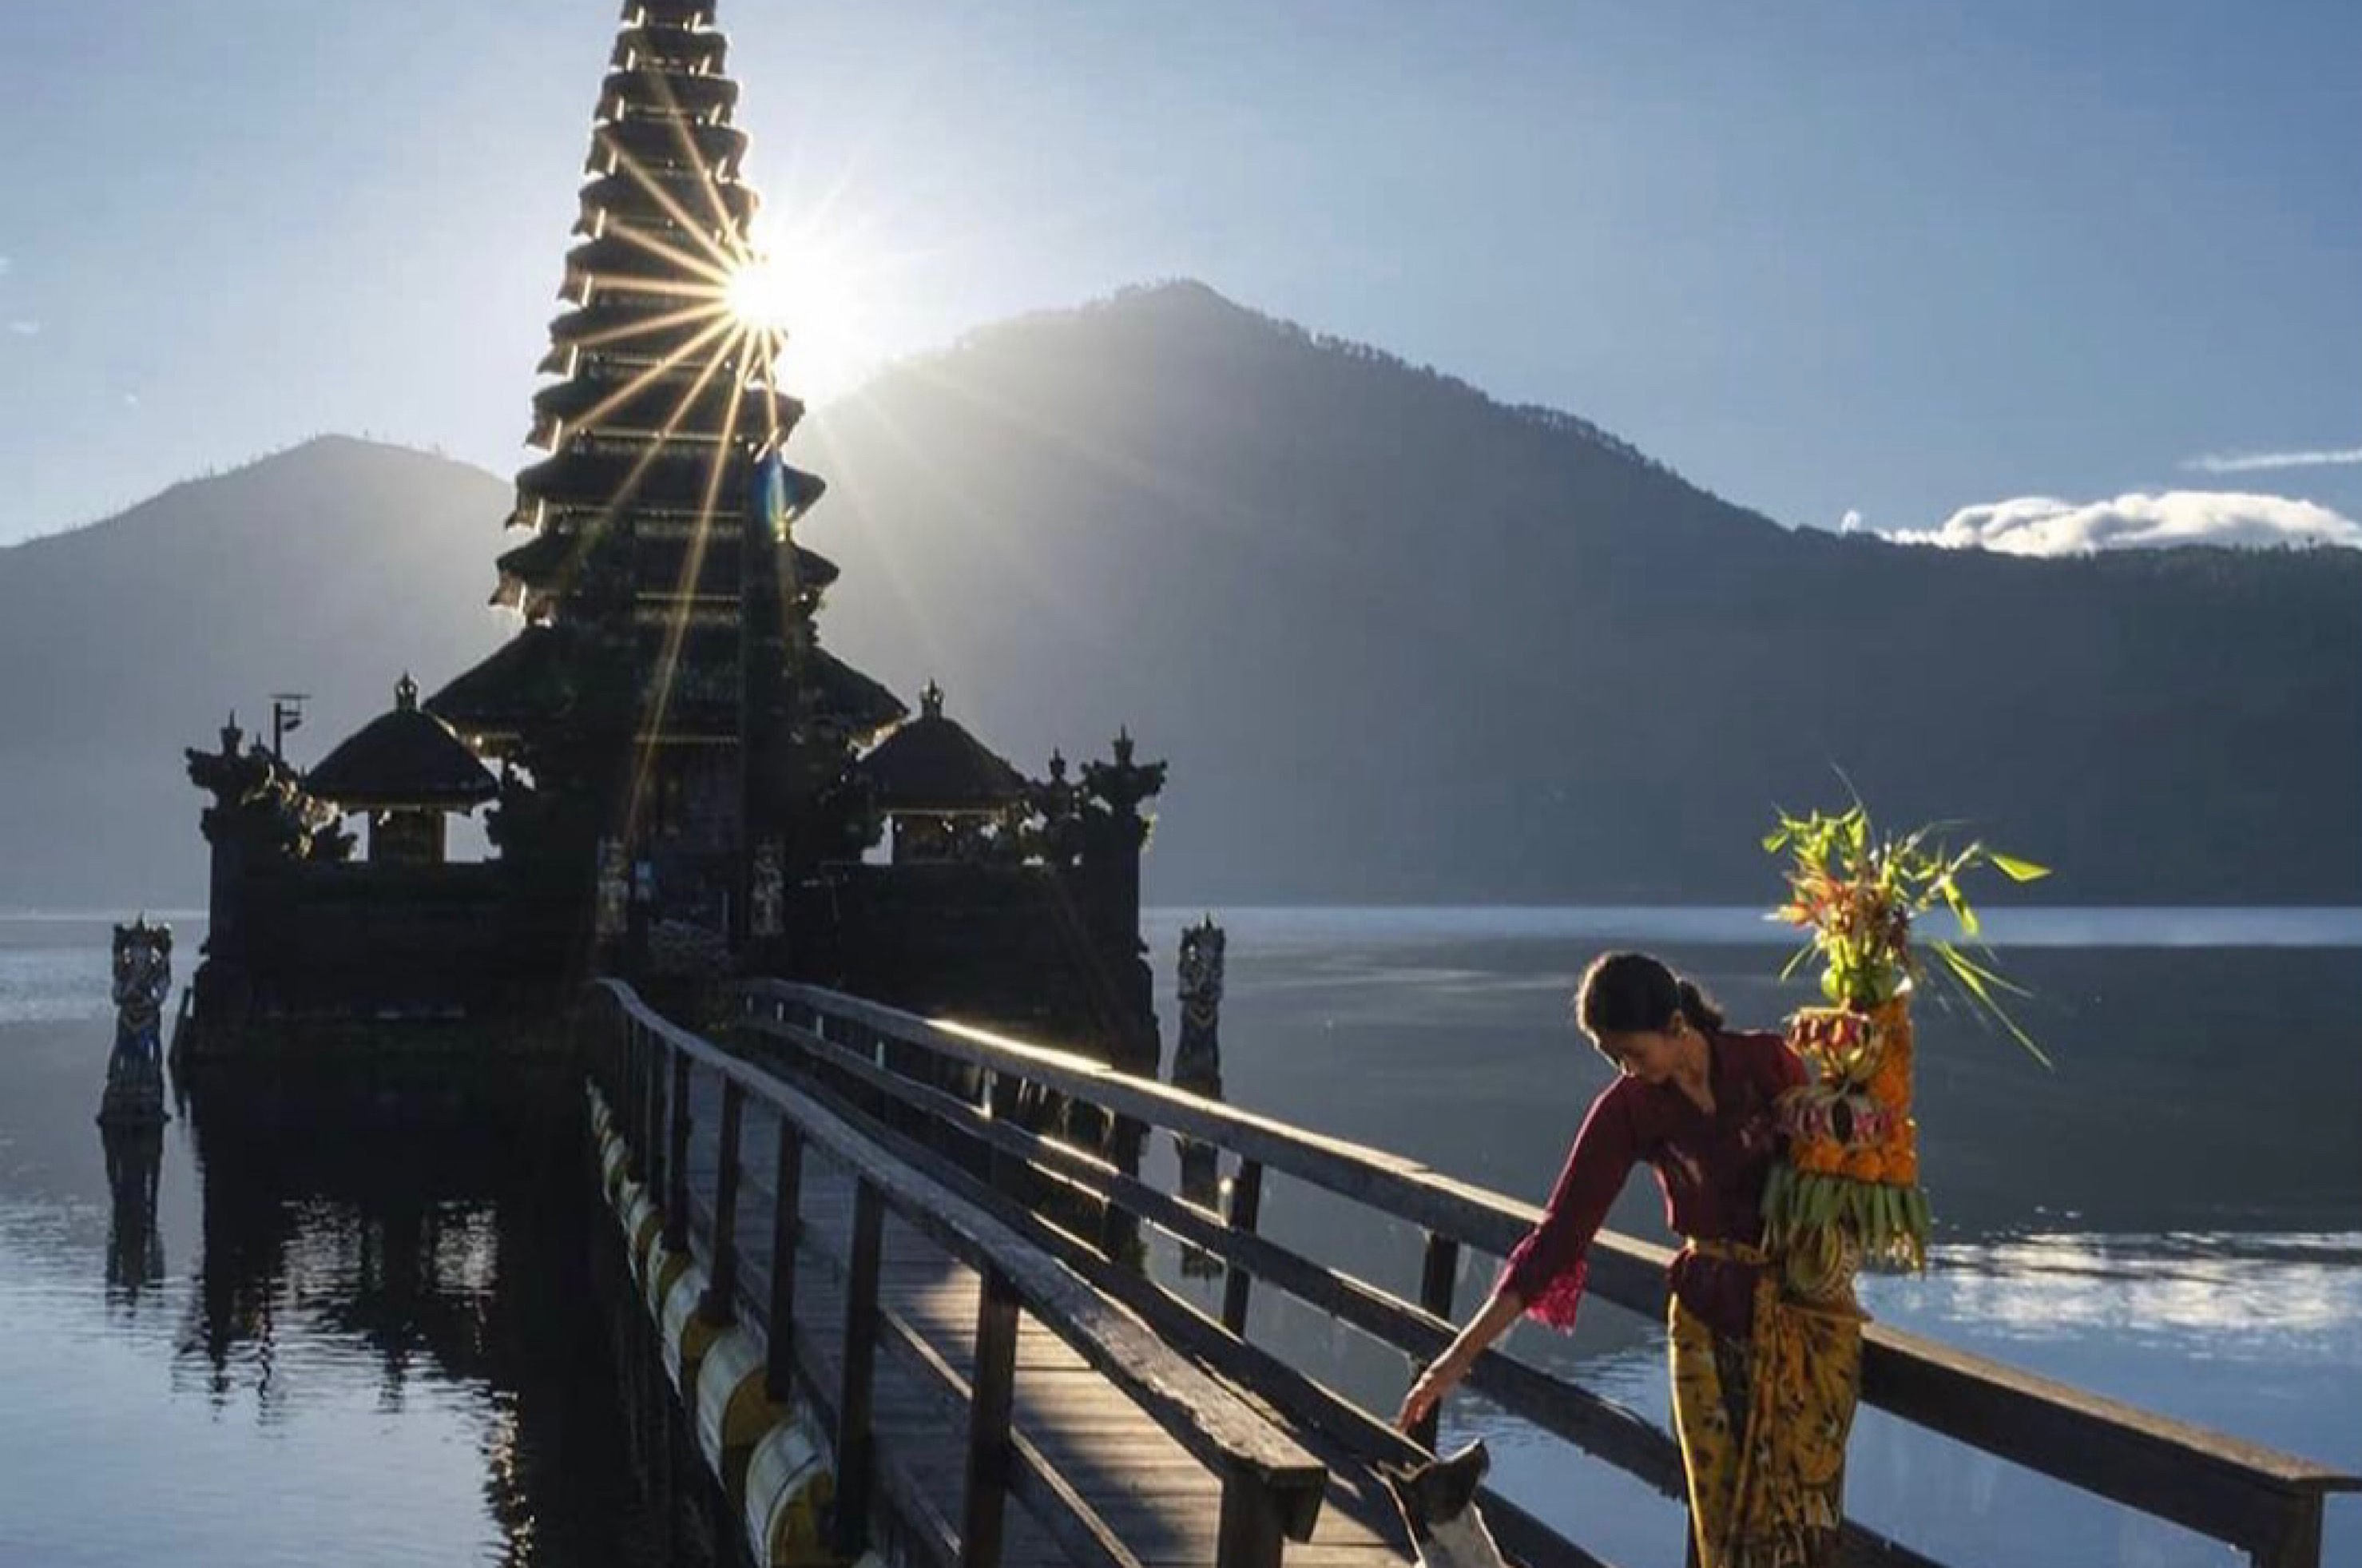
top-left (0, 909), bottom-right (2362, 1568)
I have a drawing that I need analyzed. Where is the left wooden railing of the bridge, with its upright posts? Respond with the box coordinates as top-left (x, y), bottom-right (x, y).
top-left (595, 980), bottom-right (1328, 1568)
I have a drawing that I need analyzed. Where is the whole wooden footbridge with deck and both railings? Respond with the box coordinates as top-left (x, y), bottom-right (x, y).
top-left (586, 980), bottom-right (2362, 1568)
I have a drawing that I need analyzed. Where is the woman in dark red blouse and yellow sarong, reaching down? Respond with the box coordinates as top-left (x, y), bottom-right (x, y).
top-left (1399, 951), bottom-right (1861, 1568)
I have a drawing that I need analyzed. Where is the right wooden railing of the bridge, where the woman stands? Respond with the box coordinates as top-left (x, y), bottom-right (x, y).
top-left (744, 980), bottom-right (2362, 1568)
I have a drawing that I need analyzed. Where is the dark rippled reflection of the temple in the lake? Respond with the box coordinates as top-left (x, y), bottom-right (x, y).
top-left (175, 1062), bottom-right (649, 1563)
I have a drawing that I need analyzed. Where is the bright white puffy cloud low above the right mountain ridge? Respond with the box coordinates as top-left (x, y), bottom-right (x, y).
top-left (1888, 491), bottom-right (2362, 555)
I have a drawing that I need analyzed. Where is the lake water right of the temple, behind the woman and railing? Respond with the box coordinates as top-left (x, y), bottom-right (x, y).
top-left (1150, 909), bottom-right (2362, 1568)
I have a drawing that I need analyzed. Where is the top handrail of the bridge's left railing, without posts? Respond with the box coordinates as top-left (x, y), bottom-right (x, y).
top-left (597, 980), bottom-right (1328, 1540)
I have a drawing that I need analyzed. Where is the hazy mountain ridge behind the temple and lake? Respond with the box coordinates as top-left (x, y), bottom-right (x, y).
top-left (0, 284), bottom-right (2362, 904)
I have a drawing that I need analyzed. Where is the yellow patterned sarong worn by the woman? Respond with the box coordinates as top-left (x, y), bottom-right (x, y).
top-left (1668, 1242), bottom-right (1861, 1568)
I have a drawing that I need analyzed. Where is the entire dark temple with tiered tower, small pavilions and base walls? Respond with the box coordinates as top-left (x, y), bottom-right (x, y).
top-left (177, 0), bottom-right (1165, 1072)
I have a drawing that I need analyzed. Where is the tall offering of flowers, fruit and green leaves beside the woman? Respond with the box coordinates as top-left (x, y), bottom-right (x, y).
top-left (1765, 803), bottom-right (2050, 1304)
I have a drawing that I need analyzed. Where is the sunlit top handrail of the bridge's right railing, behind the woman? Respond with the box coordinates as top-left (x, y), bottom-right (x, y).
top-left (744, 980), bottom-right (2362, 1568)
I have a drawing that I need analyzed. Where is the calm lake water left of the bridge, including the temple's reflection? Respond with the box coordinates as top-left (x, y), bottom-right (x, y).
top-left (0, 921), bottom-right (664, 1568)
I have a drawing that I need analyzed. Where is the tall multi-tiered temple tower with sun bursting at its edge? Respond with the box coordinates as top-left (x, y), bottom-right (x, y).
top-left (427, 0), bottom-right (905, 938)
